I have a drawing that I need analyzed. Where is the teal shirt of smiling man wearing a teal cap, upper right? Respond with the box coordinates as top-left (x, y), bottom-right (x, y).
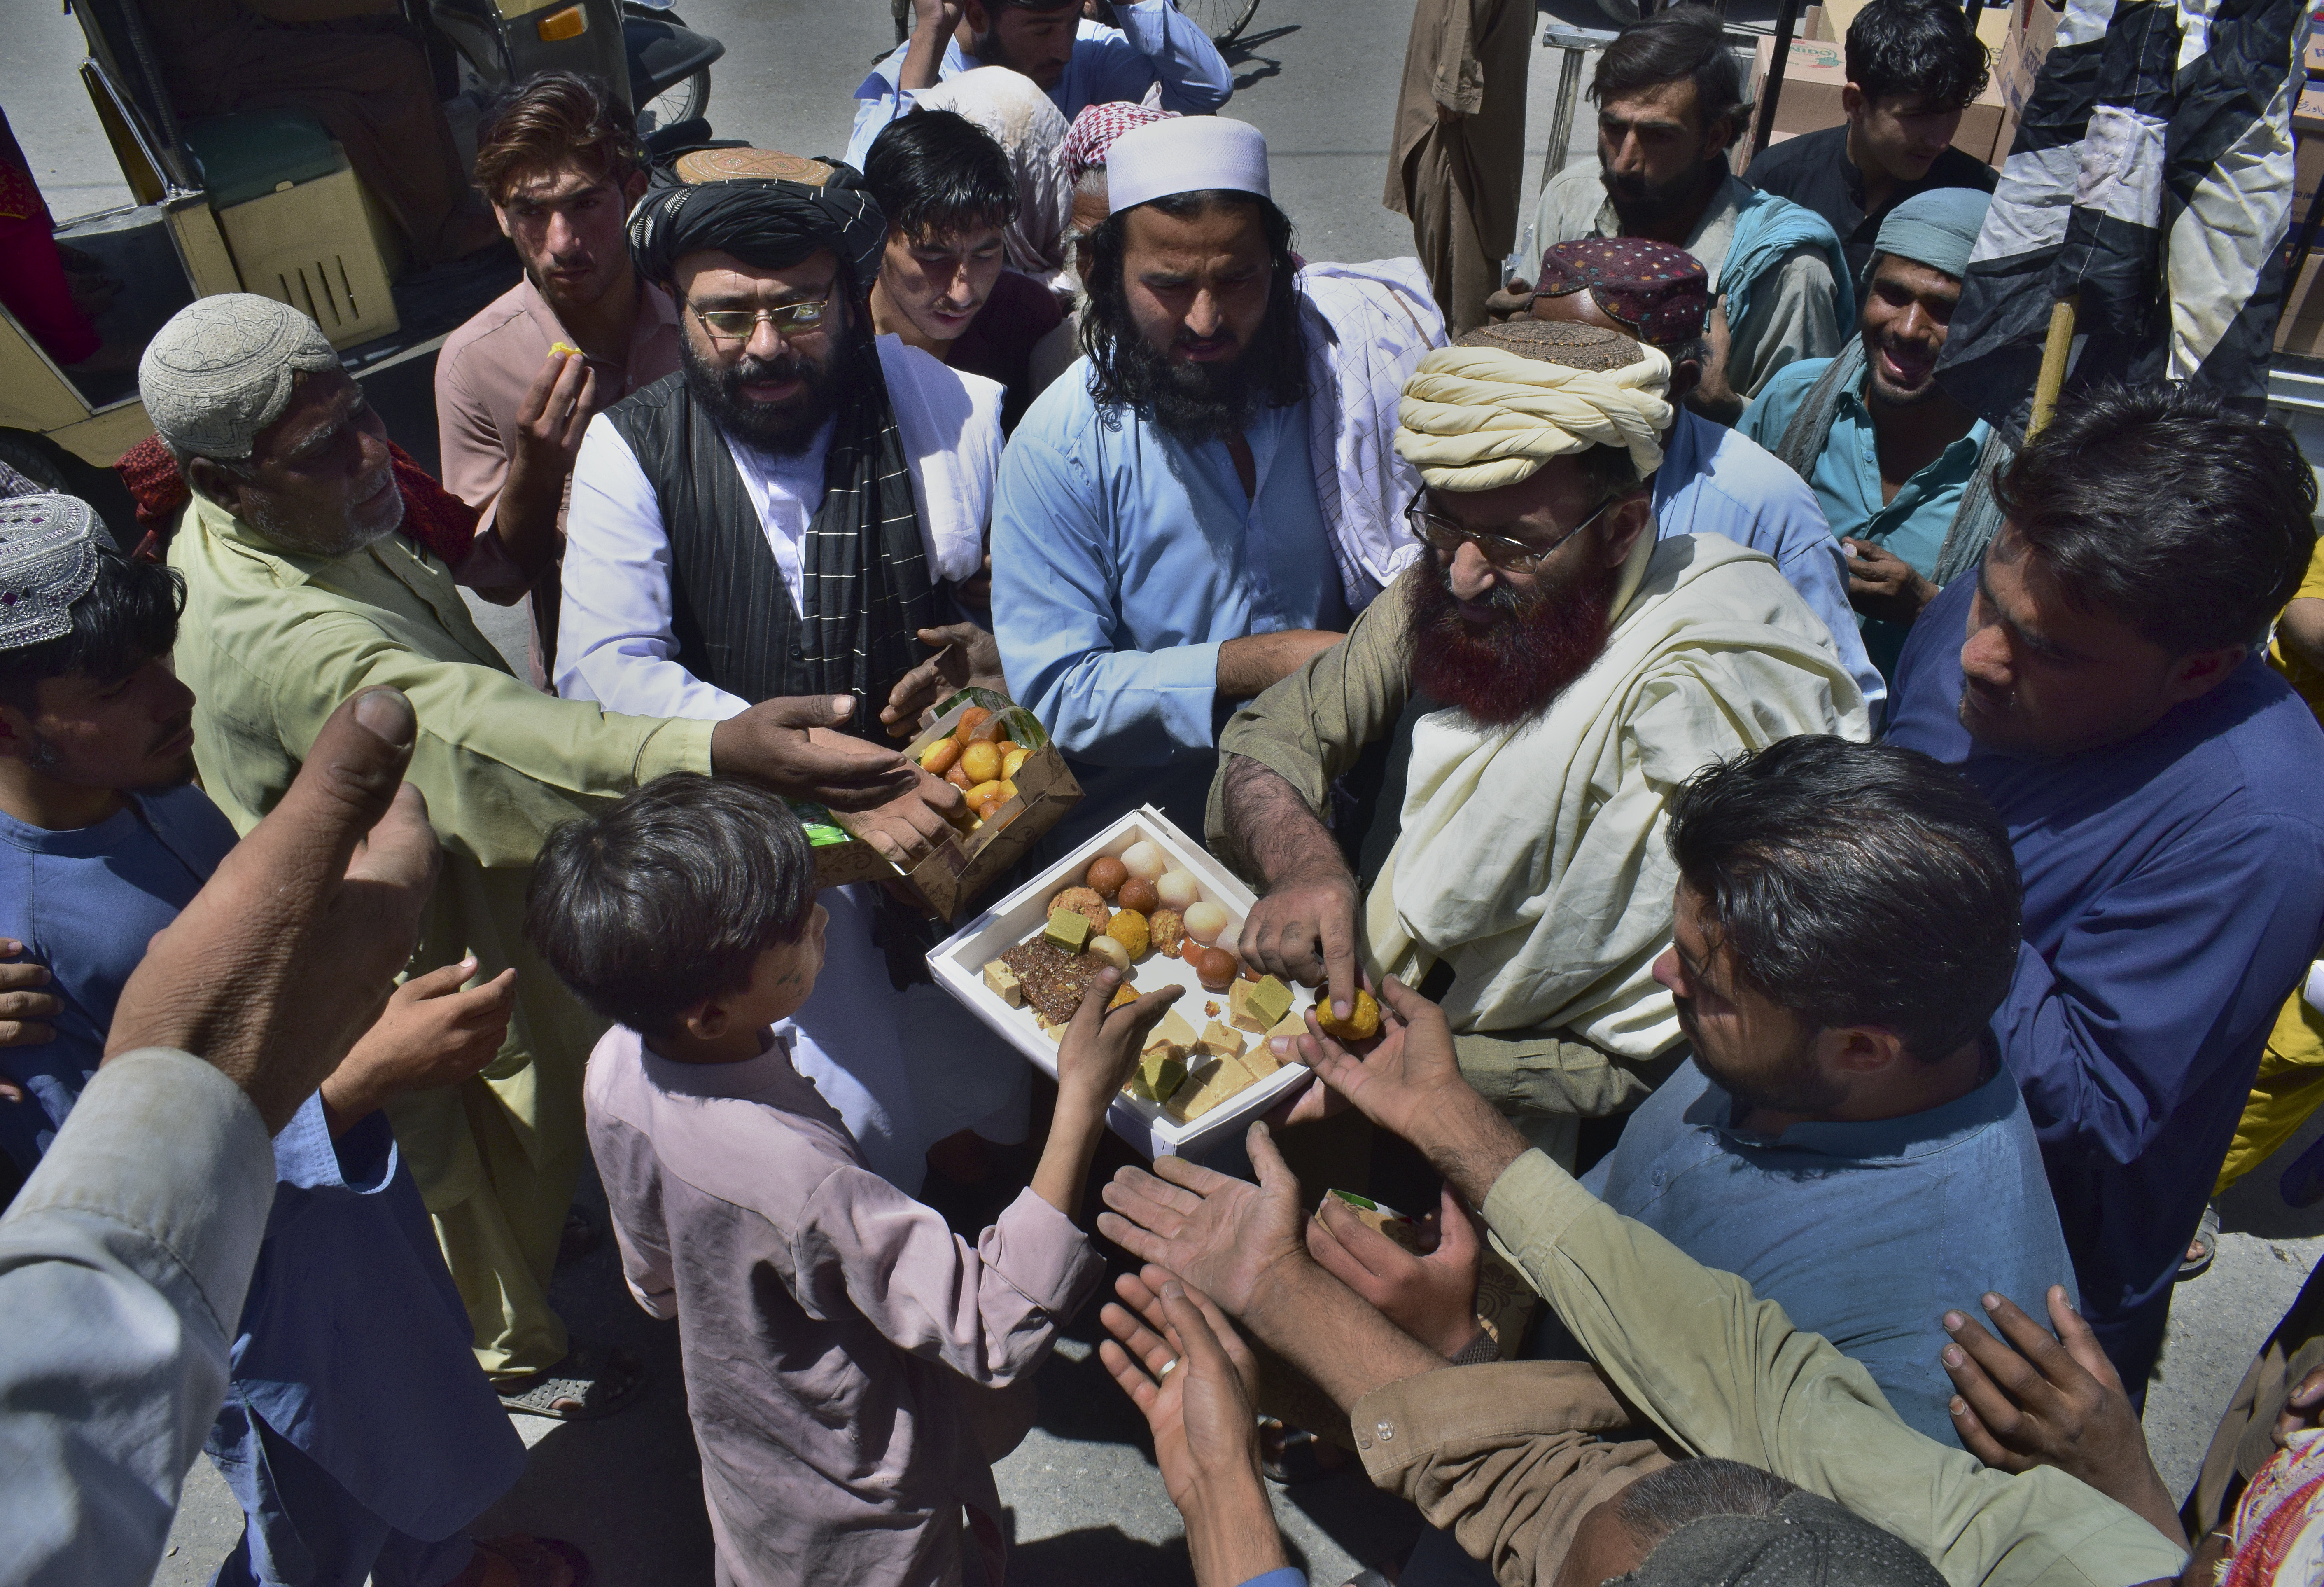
top-left (1736, 358), bottom-right (1992, 681)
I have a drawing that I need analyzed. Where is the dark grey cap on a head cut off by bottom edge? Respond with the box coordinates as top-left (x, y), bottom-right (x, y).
top-left (1615, 1494), bottom-right (1945, 1587)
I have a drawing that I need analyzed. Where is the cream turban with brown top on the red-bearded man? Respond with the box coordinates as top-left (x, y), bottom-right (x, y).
top-left (1397, 320), bottom-right (1673, 490)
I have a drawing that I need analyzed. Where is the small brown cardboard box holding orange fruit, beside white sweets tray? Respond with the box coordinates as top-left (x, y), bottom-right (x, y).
top-left (800, 688), bottom-right (1080, 925)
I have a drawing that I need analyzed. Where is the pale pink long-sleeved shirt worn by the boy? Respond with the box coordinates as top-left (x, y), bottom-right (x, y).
top-left (583, 1025), bottom-right (1101, 1587)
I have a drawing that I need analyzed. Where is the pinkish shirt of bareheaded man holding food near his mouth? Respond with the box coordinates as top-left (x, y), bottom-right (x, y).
top-left (434, 276), bottom-right (681, 544)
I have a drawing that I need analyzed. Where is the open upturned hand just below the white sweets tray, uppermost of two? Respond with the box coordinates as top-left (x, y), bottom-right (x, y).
top-left (1097, 1124), bottom-right (1309, 1318)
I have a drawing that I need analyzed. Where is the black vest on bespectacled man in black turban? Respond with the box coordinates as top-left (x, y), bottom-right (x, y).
top-left (607, 374), bottom-right (818, 713)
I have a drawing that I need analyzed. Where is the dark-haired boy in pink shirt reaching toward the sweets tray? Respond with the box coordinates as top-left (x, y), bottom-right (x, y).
top-left (527, 774), bottom-right (1176, 1587)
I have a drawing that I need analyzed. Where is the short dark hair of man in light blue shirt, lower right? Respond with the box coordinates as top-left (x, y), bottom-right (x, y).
top-left (1668, 734), bottom-right (2020, 1062)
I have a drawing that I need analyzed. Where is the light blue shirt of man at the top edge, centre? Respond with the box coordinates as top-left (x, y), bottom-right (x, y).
top-left (848, 0), bottom-right (1234, 170)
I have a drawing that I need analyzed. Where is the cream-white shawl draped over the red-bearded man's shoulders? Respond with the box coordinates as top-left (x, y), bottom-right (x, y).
top-left (1364, 534), bottom-right (1871, 1059)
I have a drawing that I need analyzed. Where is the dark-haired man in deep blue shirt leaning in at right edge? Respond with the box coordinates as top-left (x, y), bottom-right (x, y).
top-left (1887, 388), bottom-right (2324, 1401)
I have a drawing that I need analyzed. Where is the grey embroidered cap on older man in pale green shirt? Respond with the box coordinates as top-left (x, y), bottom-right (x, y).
top-left (137, 293), bottom-right (339, 458)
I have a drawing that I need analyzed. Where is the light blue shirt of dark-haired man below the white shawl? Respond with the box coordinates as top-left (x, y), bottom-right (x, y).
top-left (1583, 1053), bottom-right (2073, 1448)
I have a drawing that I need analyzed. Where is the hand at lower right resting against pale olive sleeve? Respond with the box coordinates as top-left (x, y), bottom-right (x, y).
top-left (1943, 1285), bottom-right (2187, 1547)
